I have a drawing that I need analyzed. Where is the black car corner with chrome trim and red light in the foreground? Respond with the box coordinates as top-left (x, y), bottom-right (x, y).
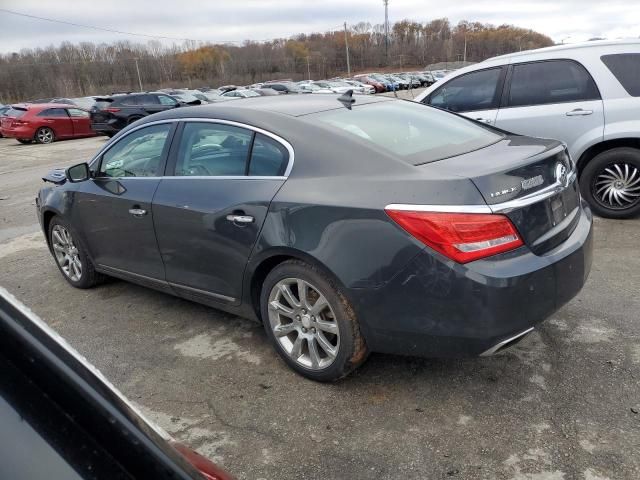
top-left (0, 287), bottom-right (232, 480)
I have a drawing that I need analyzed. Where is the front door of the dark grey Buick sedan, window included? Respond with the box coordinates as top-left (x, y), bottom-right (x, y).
top-left (73, 123), bottom-right (175, 280)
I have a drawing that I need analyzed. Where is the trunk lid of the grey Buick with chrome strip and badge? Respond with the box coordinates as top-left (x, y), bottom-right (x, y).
top-left (422, 135), bottom-right (580, 254)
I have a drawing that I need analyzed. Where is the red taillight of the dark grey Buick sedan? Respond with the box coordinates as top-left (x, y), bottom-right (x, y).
top-left (385, 209), bottom-right (523, 263)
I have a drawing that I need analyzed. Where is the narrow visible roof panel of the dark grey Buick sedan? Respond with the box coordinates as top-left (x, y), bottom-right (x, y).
top-left (147, 94), bottom-right (395, 120)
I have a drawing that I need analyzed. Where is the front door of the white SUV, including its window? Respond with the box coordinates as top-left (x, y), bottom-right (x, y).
top-left (423, 67), bottom-right (506, 125)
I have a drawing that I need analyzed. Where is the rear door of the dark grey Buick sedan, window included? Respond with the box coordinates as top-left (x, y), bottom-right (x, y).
top-left (153, 121), bottom-right (293, 305)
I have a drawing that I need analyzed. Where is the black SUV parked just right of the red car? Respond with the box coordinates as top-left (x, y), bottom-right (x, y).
top-left (91, 92), bottom-right (189, 137)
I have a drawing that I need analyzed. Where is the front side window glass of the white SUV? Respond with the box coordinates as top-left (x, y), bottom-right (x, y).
top-left (427, 68), bottom-right (502, 112)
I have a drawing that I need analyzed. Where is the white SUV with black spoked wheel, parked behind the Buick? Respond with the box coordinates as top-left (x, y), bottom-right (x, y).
top-left (416, 40), bottom-right (640, 218)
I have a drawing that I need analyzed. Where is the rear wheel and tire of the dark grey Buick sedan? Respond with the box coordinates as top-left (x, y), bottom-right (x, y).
top-left (260, 260), bottom-right (368, 382)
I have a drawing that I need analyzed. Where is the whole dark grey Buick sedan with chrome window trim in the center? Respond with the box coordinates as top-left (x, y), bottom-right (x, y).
top-left (37, 94), bottom-right (592, 380)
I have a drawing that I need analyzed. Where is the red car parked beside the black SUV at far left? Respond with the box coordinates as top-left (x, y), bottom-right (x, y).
top-left (0, 103), bottom-right (96, 143)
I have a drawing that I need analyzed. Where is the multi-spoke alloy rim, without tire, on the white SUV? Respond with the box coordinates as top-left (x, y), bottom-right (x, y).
top-left (593, 163), bottom-right (640, 210)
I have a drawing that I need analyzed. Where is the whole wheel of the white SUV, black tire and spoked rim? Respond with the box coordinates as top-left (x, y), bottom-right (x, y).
top-left (580, 147), bottom-right (640, 218)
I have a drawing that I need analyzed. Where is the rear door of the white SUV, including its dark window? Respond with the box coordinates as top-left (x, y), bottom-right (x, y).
top-left (496, 60), bottom-right (604, 159)
